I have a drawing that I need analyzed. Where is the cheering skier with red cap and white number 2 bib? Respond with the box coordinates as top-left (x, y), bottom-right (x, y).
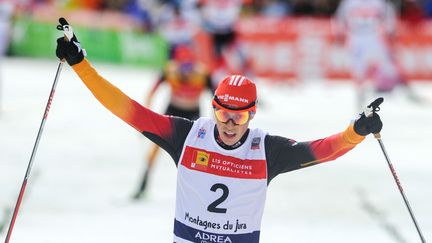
top-left (56, 19), bottom-right (382, 243)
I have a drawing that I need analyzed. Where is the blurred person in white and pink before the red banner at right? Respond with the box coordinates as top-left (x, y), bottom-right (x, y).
top-left (336, 0), bottom-right (401, 109)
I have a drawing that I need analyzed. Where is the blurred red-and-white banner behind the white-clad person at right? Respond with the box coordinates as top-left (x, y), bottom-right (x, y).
top-left (219, 18), bottom-right (432, 80)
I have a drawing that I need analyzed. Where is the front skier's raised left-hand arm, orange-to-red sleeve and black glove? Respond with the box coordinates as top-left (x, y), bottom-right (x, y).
top-left (56, 19), bottom-right (192, 162)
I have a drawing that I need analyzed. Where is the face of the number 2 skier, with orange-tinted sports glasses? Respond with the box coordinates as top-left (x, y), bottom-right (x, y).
top-left (215, 109), bottom-right (252, 145)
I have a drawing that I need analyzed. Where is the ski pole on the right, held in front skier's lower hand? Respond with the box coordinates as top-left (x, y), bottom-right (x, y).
top-left (365, 98), bottom-right (426, 243)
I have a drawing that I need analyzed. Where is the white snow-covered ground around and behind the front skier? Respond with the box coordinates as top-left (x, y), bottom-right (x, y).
top-left (0, 58), bottom-right (432, 243)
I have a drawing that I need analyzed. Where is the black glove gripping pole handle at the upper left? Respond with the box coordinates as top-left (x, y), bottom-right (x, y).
top-left (56, 18), bottom-right (86, 66)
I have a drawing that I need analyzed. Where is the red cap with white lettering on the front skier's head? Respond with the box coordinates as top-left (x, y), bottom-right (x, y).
top-left (212, 75), bottom-right (257, 112)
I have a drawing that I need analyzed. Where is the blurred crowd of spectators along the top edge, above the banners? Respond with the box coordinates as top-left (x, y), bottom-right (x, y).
top-left (5, 0), bottom-right (432, 31)
